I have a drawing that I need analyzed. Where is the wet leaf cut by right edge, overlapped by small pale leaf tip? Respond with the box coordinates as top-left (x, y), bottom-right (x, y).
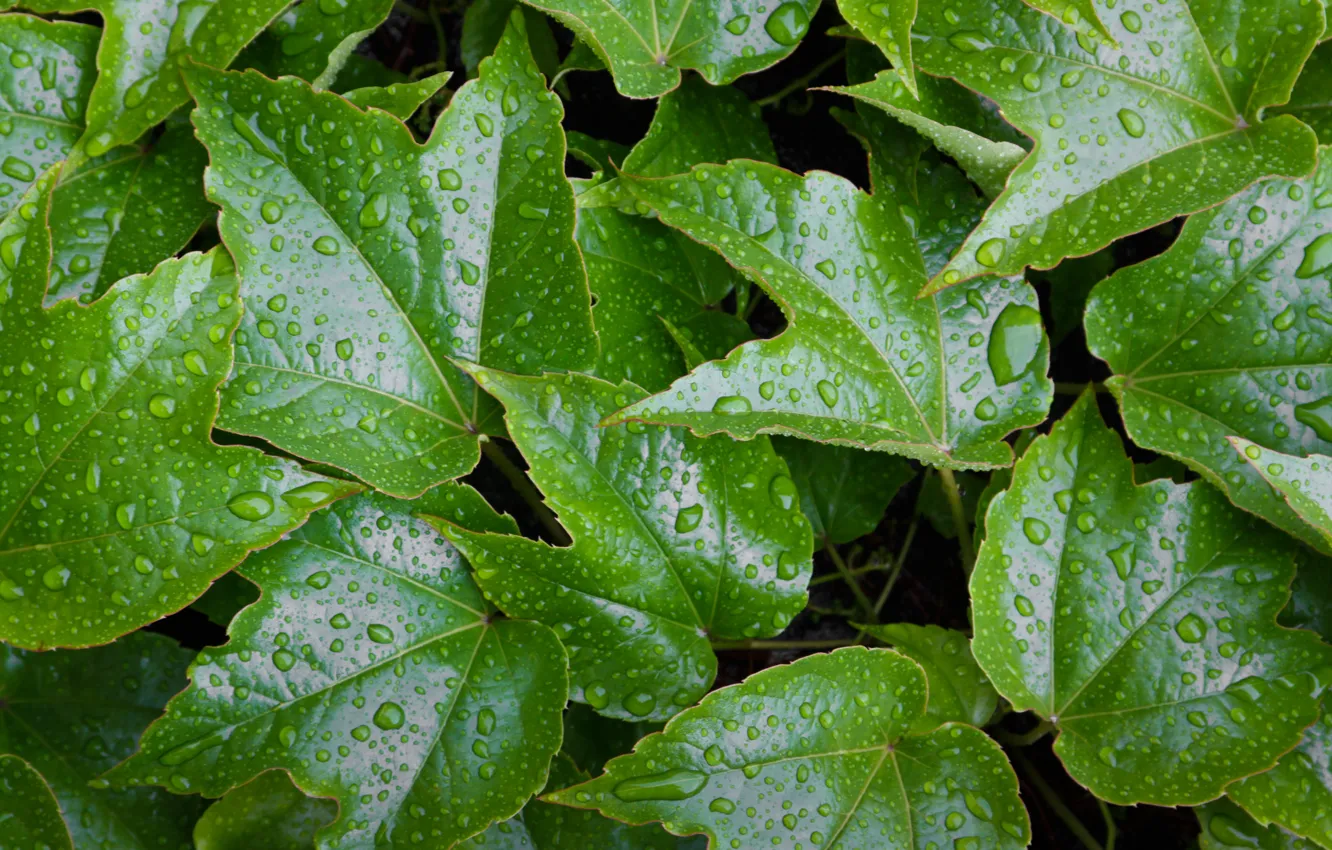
top-left (1086, 156), bottom-right (1332, 546)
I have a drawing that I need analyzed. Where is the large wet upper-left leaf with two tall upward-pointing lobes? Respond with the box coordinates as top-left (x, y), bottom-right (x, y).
top-left (189, 15), bottom-right (597, 497)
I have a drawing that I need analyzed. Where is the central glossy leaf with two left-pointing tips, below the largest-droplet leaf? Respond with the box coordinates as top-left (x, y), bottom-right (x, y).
top-left (441, 366), bottom-right (813, 721)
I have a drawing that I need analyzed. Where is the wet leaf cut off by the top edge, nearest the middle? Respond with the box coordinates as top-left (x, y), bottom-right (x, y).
top-left (525, 0), bottom-right (819, 97)
